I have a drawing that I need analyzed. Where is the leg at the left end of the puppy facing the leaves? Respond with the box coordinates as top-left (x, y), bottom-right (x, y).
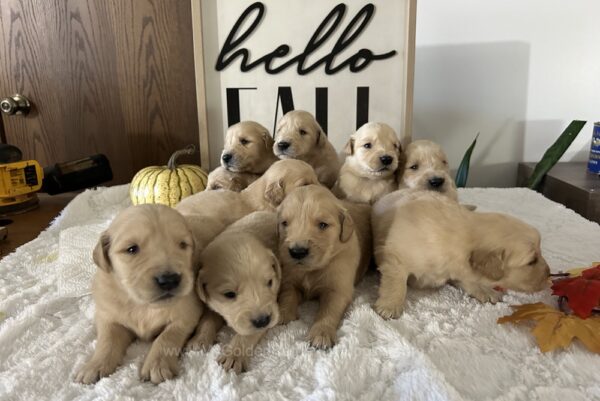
top-left (375, 262), bottom-right (408, 319)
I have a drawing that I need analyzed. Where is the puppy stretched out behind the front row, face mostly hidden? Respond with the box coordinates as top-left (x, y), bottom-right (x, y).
top-left (175, 160), bottom-right (318, 261)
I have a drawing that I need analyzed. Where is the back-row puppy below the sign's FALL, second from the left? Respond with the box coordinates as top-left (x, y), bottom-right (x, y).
top-left (273, 110), bottom-right (340, 188)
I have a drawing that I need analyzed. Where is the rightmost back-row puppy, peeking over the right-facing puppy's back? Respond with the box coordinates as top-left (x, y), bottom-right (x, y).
top-left (397, 140), bottom-right (458, 199)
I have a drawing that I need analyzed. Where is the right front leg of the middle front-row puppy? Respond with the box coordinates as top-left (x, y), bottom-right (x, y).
top-left (308, 289), bottom-right (352, 349)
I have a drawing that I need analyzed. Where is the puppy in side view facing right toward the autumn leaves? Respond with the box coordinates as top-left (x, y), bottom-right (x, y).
top-left (373, 190), bottom-right (550, 318)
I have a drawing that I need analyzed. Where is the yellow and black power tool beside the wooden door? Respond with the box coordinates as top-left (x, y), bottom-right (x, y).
top-left (0, 144), bottom-right (113, 215)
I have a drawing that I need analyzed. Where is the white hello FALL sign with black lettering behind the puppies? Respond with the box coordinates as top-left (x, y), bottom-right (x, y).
top-left (201, 0), bottom-right (414, 167)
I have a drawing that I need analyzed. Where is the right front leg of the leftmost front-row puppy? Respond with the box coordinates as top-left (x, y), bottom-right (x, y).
top-left (140, 322), bottom-right (194, 384)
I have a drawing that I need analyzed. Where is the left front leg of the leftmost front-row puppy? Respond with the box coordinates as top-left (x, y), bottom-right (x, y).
top-left (75, 320), bottom-right (135, 384)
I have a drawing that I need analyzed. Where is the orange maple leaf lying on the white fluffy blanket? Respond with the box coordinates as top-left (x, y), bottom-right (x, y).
top-left (498, 302), bottom-right (600, 354)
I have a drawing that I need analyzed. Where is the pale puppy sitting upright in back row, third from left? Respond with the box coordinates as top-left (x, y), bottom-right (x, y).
top-left (333, 123), bottom-right (402, 204)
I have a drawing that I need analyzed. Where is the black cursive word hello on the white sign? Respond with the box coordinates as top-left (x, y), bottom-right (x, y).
top-left (215, 2), bottom-right (397, 75)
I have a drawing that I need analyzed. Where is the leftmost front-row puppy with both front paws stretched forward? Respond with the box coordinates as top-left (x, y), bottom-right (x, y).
top-left (75, 205), bottom-right (203, 384)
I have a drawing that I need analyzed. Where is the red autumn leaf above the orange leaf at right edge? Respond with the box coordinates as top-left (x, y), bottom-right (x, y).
top-left (552, 266), bottom-right (600, 319)
